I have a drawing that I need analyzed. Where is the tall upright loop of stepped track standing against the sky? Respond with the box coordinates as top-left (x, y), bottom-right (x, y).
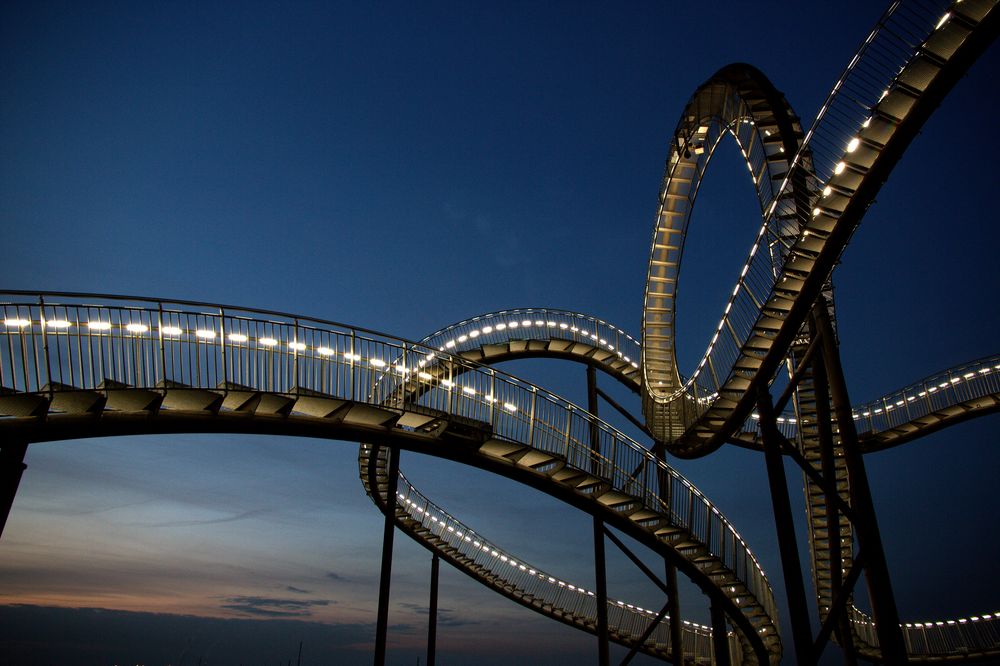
top-left (642, 64), bottom-right (802, 442)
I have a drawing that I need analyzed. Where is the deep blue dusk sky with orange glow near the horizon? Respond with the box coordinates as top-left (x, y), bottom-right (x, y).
top-left (0, 0), bottom-right (1000, 664)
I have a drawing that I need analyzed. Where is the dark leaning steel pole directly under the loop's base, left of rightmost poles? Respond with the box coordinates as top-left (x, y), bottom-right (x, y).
top-left (757, 389), bottom-right (814, 666)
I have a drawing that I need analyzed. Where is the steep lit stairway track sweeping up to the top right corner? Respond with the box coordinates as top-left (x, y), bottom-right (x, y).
top-left (644, 0), bottom-right (1000, 457)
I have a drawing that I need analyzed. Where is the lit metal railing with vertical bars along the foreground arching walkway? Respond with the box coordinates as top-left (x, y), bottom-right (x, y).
top-left (0, 293), bottom-right (777, 656)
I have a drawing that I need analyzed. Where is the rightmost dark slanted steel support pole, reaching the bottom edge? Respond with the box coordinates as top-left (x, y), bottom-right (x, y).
top-left (814, 299), bottom-right (907, 664)
